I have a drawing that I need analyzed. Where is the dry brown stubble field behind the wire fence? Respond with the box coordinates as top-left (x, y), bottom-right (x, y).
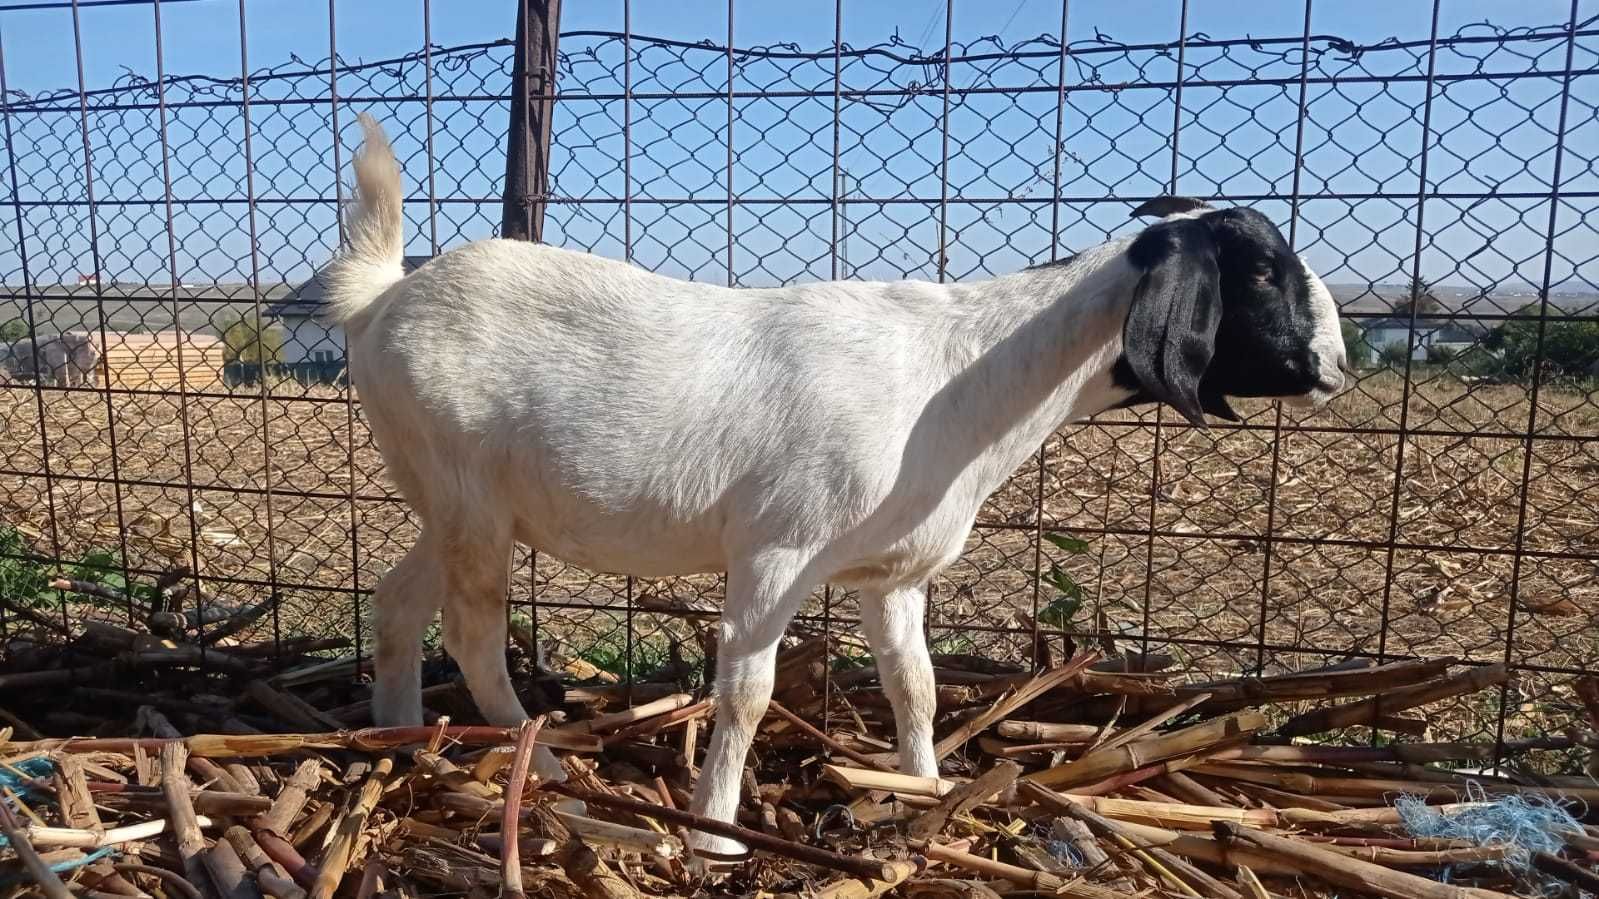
top-left (0, 371), bottom-right (1599, 761)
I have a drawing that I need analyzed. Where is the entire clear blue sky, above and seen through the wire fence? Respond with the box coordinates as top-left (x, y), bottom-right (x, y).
top-left (0, 0), bottom-right (1599, 307)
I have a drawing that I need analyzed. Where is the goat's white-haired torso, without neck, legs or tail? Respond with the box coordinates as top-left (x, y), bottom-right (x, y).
top-left (350, 240), bottom-right (942, 574)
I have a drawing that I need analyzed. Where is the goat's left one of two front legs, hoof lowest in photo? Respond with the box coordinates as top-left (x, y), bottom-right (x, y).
top-left (692, 557), bottom-right (811, 854)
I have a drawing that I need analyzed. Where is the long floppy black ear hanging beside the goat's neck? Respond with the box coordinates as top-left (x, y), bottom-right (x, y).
top-left (1122, 221), bottom-right (1236, 427)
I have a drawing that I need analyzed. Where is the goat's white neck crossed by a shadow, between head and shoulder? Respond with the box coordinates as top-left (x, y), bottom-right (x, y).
top-left (934, 251), bottom-right (1134, 496)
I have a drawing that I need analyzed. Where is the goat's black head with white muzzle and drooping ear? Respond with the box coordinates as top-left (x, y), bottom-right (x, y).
top-left (1116, 197), bottom-right (1348, 427)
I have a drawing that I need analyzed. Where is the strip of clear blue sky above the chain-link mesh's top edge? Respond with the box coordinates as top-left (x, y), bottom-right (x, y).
top-left (0, 0), bottom-right (1573, 90)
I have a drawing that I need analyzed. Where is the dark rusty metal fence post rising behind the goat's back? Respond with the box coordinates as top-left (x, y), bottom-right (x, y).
top-left (500, 0), bottom-right (561, 242)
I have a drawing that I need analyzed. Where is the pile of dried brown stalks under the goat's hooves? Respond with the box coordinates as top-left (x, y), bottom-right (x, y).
top-left (0, 584), bottom-right (1599, 899)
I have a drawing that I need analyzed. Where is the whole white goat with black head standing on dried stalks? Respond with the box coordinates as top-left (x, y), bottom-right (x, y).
top-left (328, 115), bottom-right (1346, 851)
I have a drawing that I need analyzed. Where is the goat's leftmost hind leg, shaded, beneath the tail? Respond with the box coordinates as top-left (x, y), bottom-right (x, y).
top-left (373, 526), bottom-right (445, 726)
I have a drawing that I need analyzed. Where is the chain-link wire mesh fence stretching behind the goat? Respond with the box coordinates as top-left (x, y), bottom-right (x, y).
top-left (0, 3), bottom-right (1599, 766)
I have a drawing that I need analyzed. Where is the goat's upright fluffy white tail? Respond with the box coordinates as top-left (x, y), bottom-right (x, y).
top-left (323, 112), bottom-right (405, 325)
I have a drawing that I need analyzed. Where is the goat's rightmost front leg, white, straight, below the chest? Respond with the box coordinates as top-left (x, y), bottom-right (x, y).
top-left (860, 589), bottom-right (939, 777)
